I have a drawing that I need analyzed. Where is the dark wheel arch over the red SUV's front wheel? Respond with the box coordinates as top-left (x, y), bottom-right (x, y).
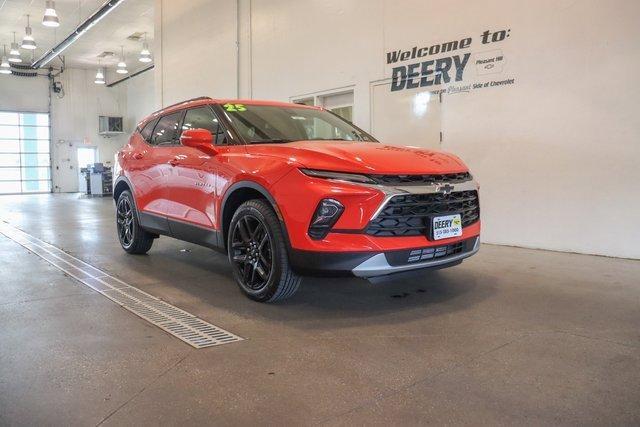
top-left (220, 181), bottom-right (290, 249)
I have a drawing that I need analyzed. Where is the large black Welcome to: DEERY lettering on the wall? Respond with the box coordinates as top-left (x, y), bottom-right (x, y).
top-left (386, 29), bottom-right (511, 92)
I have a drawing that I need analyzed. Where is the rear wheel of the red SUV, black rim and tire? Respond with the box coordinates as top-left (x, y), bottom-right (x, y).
top-left (116, 190), bottom-right (155, 255)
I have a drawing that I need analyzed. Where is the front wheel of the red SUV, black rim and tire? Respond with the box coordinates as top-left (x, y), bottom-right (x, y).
top-left (227, 199), bottom-right (301, 302)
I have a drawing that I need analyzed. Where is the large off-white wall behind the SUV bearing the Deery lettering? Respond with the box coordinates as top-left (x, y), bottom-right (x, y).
top-left (156, 0), bottom-right (640, 258)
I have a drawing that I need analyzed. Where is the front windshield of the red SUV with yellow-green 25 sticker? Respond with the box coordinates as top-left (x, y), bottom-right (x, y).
top-left (222, 104), bottom-right (375, 144)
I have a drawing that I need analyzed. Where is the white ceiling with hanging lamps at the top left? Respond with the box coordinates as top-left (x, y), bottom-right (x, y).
top-left (0, 0), bottom-right (154, 71)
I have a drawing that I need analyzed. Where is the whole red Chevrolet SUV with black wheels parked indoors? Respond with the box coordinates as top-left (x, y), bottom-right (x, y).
top-left (113, 97), bottom-right (480, 301)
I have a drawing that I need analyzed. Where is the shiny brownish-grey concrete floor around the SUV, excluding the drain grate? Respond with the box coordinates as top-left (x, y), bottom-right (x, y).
top-left (0, 195), bottom-right (640, 425)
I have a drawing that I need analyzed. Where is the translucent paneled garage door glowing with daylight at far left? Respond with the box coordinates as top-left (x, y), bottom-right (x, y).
top-left (0, 111), bottom-right (51, 194)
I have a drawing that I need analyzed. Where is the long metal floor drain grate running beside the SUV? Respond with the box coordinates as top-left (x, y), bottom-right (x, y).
top-left (0, 221), bottom-right (243, 348)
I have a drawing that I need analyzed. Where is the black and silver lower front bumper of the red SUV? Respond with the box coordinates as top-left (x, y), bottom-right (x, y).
top-left (289, 236), bottom-right (480, 278)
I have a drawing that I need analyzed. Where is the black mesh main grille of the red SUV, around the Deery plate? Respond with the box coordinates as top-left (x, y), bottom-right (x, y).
top-left (366, 190), bottom-right (480, 236)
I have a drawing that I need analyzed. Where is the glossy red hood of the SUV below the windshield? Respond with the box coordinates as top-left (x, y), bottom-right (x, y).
top-left (246, 141), bottom-right (467, 174)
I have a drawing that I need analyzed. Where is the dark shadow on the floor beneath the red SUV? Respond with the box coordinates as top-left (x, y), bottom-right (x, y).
top-left (112, 242), bottom-right (495, 329)
